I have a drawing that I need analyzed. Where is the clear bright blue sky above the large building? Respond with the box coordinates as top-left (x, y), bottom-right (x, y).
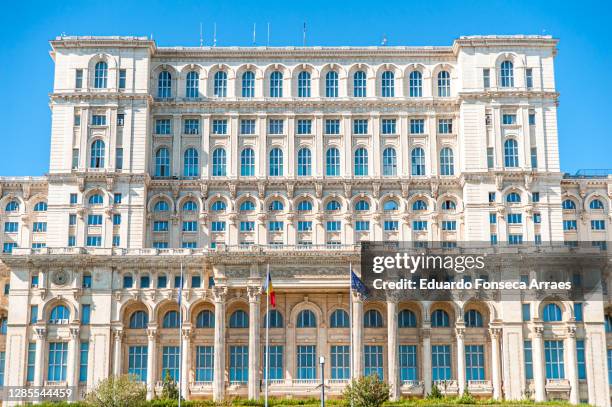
top-left (0, 0), bottom-right (612, 176)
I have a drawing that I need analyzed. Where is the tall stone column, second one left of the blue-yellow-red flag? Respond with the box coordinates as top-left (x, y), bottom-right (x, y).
top-left (212, 286), bottom-right (227, 401)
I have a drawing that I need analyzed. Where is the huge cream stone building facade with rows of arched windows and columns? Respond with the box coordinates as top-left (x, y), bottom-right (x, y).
top-left (0, 36), bottom-right (612, 406)
